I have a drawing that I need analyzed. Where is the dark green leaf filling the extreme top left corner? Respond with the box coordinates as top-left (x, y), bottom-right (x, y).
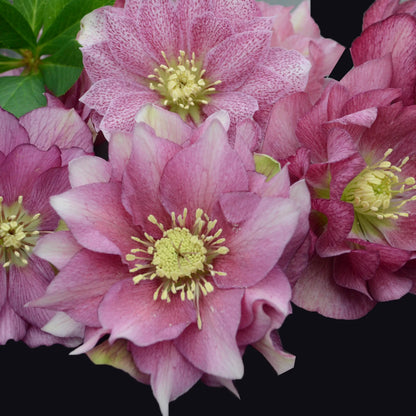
top-left (0, 0), bottom-right (36, 49)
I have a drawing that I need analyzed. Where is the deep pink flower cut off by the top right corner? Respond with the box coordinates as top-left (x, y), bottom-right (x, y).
top-left (351, 0), bottom-right (416, 105)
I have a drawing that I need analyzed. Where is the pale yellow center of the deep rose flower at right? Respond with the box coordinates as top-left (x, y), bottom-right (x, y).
top-left (342, 149), bottom-right (416, 220)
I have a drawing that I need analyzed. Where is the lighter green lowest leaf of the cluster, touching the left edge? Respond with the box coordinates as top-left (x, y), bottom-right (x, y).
top-left (0, 75), bottom-right (46, 117)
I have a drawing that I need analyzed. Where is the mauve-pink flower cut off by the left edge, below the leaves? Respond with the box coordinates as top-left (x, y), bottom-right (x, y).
top-left (0, 107), bottom-right (92, 347)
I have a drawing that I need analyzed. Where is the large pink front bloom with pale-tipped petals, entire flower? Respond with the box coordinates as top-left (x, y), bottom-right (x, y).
top-left (31, 106), bottom-right (309, 415)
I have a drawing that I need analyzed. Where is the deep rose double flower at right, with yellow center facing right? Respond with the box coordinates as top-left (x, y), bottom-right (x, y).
top-left (261, 56), bottom-right (416, 319)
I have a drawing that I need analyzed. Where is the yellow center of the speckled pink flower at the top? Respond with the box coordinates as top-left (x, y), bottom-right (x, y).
top-left (148, 50), bottom-right (221, 124)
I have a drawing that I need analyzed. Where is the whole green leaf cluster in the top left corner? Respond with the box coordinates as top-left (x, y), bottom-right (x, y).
top-left (0, 0), bottom-right (115, 117)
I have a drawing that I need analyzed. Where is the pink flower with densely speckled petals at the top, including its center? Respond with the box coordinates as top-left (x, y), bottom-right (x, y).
top-left (79, 0), bottom-right (310, 132)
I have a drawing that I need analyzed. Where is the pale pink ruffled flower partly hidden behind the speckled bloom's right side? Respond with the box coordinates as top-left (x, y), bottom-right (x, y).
top-left (258, 0), bottom-right (344, 102)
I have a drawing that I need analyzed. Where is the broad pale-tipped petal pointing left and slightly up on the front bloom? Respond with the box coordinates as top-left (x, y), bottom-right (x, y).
top-left (51, 183), bottom-right (138, 254)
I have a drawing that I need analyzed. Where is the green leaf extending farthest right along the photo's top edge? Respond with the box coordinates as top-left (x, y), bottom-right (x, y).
top-left (39, 0), bottom-right (114, 51)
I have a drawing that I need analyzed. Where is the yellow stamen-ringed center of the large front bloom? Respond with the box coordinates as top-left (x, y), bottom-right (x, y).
top-left (126, 208), bottom-right (229, 328)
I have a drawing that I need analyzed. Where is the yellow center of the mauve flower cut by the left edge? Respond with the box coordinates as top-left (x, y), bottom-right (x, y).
top-left (0, 196), bottom-right (40, 268)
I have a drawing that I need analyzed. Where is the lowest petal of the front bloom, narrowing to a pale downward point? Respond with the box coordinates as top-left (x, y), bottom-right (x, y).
top-left (131, 341), bottom-right (202, 416)
